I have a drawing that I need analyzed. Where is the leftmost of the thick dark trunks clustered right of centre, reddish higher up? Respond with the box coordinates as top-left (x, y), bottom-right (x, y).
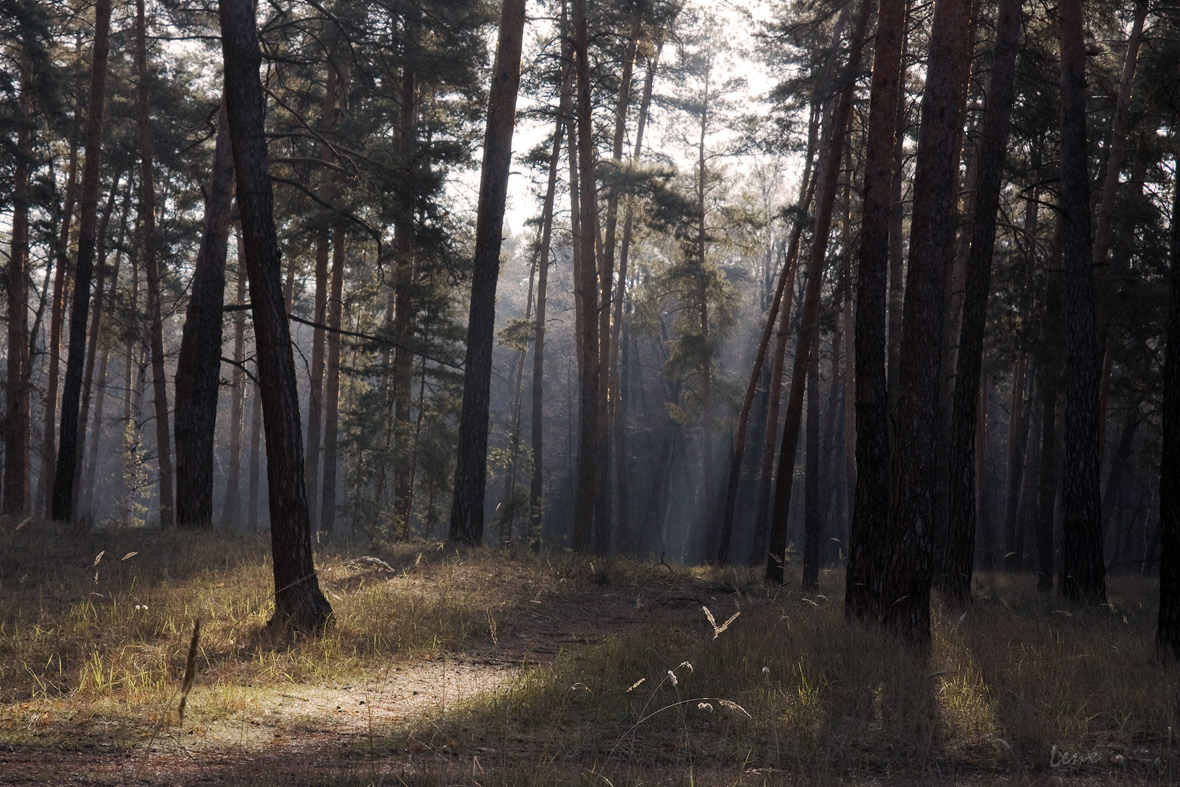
top-left (844, 0), bottom-right (906, 618)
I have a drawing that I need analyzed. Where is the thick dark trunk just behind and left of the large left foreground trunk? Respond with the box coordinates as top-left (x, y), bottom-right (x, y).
top-left (173, 100), bottom-right (234, 527)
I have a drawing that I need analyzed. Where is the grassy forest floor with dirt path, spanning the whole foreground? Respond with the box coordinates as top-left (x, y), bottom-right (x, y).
top-left (0, 520), bottom-right (1180, 786)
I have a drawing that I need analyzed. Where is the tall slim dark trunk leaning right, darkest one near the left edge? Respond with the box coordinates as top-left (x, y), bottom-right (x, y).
top-left (51, 0), bottom-right (111, 523)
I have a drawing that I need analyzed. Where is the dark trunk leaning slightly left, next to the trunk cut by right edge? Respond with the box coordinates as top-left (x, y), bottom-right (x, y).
top-left (1057, 0), bottom-right (1106, 603)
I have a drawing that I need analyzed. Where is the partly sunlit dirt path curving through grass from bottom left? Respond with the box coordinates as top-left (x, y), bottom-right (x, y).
top-left (0, 566), bottom-right (733, 785)
